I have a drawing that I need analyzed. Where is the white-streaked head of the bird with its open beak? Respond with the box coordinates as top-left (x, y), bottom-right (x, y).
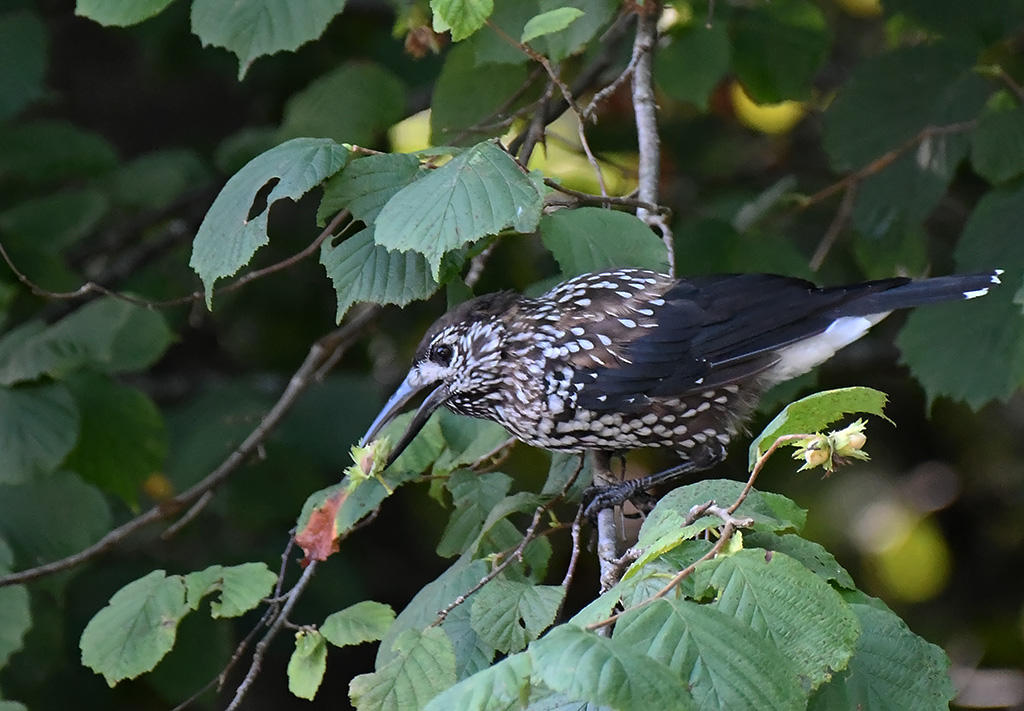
top-left (362, 292), bottom-right (519, 467)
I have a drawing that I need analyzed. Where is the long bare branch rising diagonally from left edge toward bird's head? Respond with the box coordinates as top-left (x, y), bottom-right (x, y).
top-left (0, 309), bottom-right (377, 587)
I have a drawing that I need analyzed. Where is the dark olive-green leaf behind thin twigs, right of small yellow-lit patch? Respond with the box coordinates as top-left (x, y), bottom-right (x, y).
top-left (430, 43), bottom-right (526, 145)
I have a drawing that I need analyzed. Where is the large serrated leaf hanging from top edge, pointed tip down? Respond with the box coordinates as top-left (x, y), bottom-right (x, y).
top-left (191, 0), bottom-right (345, 81)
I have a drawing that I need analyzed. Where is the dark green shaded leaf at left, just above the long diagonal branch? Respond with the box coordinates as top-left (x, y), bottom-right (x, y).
top-left (67, 373), bottom-right (167, 505)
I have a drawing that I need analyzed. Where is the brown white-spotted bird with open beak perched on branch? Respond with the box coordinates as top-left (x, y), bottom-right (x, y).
top-left (361, 267), bottom-right (1001, 515)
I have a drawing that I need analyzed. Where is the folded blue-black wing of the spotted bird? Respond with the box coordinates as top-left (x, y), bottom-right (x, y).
top-left (566, 275), bottom-right (906, 411)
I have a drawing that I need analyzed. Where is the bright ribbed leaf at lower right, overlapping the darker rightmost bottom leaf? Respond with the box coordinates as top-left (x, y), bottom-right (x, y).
top-left (693, 549), bottom-right (860, 688)
